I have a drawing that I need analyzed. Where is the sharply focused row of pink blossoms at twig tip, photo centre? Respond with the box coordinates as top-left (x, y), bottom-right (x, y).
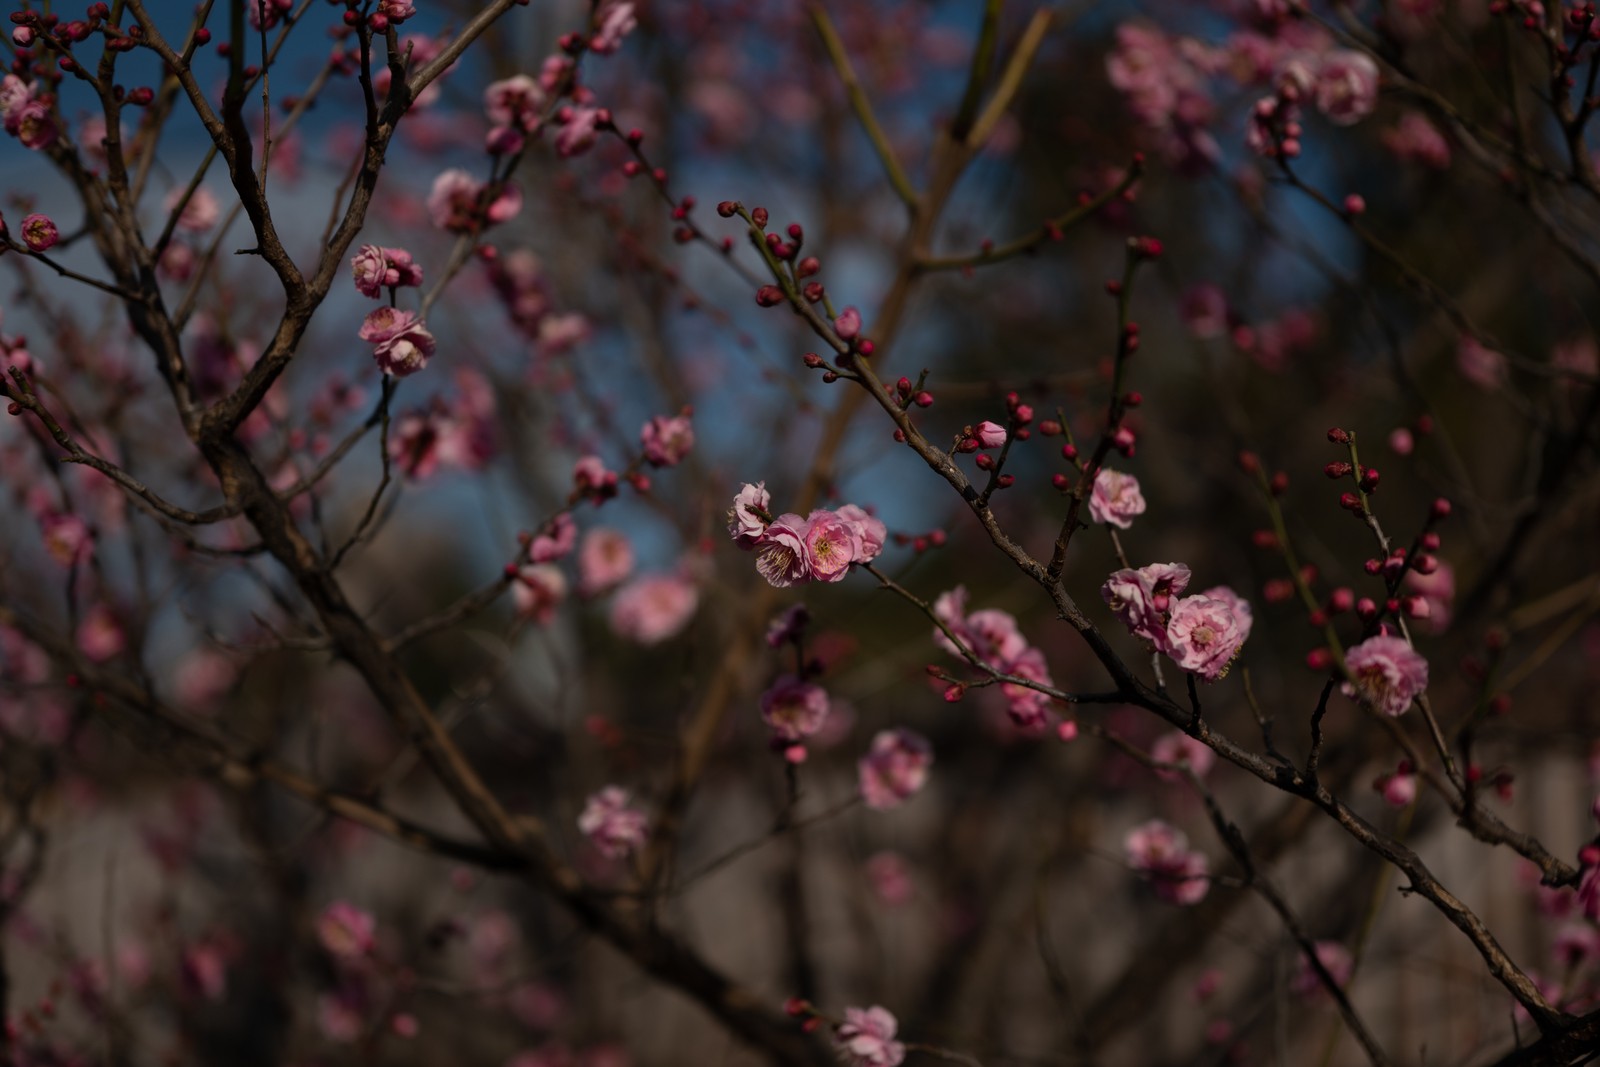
top-left (728, 482), bottom-right (888, 589)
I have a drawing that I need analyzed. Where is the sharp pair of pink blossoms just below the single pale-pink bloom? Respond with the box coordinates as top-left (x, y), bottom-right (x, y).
top-left (1101, 563), bottom-right (1254, 681)
